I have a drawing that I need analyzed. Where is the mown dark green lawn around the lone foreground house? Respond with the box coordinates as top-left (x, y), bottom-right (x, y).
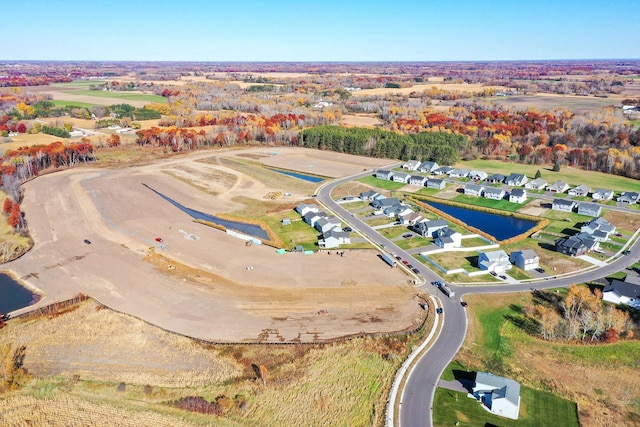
top-left (433, 387), bottom-right (579, 427)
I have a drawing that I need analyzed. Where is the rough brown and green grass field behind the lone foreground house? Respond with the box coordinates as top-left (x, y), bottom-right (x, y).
top-left (450, 292), bottom-right (640, 426)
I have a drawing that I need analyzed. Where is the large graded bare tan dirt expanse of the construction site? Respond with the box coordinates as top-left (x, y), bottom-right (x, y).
top-left (7, 147), bottom-right (421, 342)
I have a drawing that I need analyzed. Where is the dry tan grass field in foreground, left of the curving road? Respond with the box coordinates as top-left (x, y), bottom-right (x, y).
top-left (0, 301), bottom-right (421, 427)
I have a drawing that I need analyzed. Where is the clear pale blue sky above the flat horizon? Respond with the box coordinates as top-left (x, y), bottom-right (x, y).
top-left (5, 0), bottom-right (640, 61)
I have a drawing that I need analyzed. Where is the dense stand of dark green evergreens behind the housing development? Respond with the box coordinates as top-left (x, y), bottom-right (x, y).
top-left (298, 126), bottom-right (469, 165)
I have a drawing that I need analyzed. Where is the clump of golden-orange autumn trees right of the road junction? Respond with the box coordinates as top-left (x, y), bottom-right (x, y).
top-left (524, 285), bottom-right (633, 342)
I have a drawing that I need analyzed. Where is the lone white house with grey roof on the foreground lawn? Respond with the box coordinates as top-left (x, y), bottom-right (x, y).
top-left (473, 372), bottom-right (520, 420)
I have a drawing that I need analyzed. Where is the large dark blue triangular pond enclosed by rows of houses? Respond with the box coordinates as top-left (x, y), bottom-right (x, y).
top-left (426, 201), bottom-right (537, 241)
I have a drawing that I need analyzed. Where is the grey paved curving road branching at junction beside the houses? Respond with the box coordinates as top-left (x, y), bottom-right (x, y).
top-left (316, 170), bottom-right (640, 427)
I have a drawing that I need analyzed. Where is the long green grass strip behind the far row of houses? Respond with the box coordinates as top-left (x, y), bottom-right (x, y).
top-left (456, 159), bottom-right (640, 192)
